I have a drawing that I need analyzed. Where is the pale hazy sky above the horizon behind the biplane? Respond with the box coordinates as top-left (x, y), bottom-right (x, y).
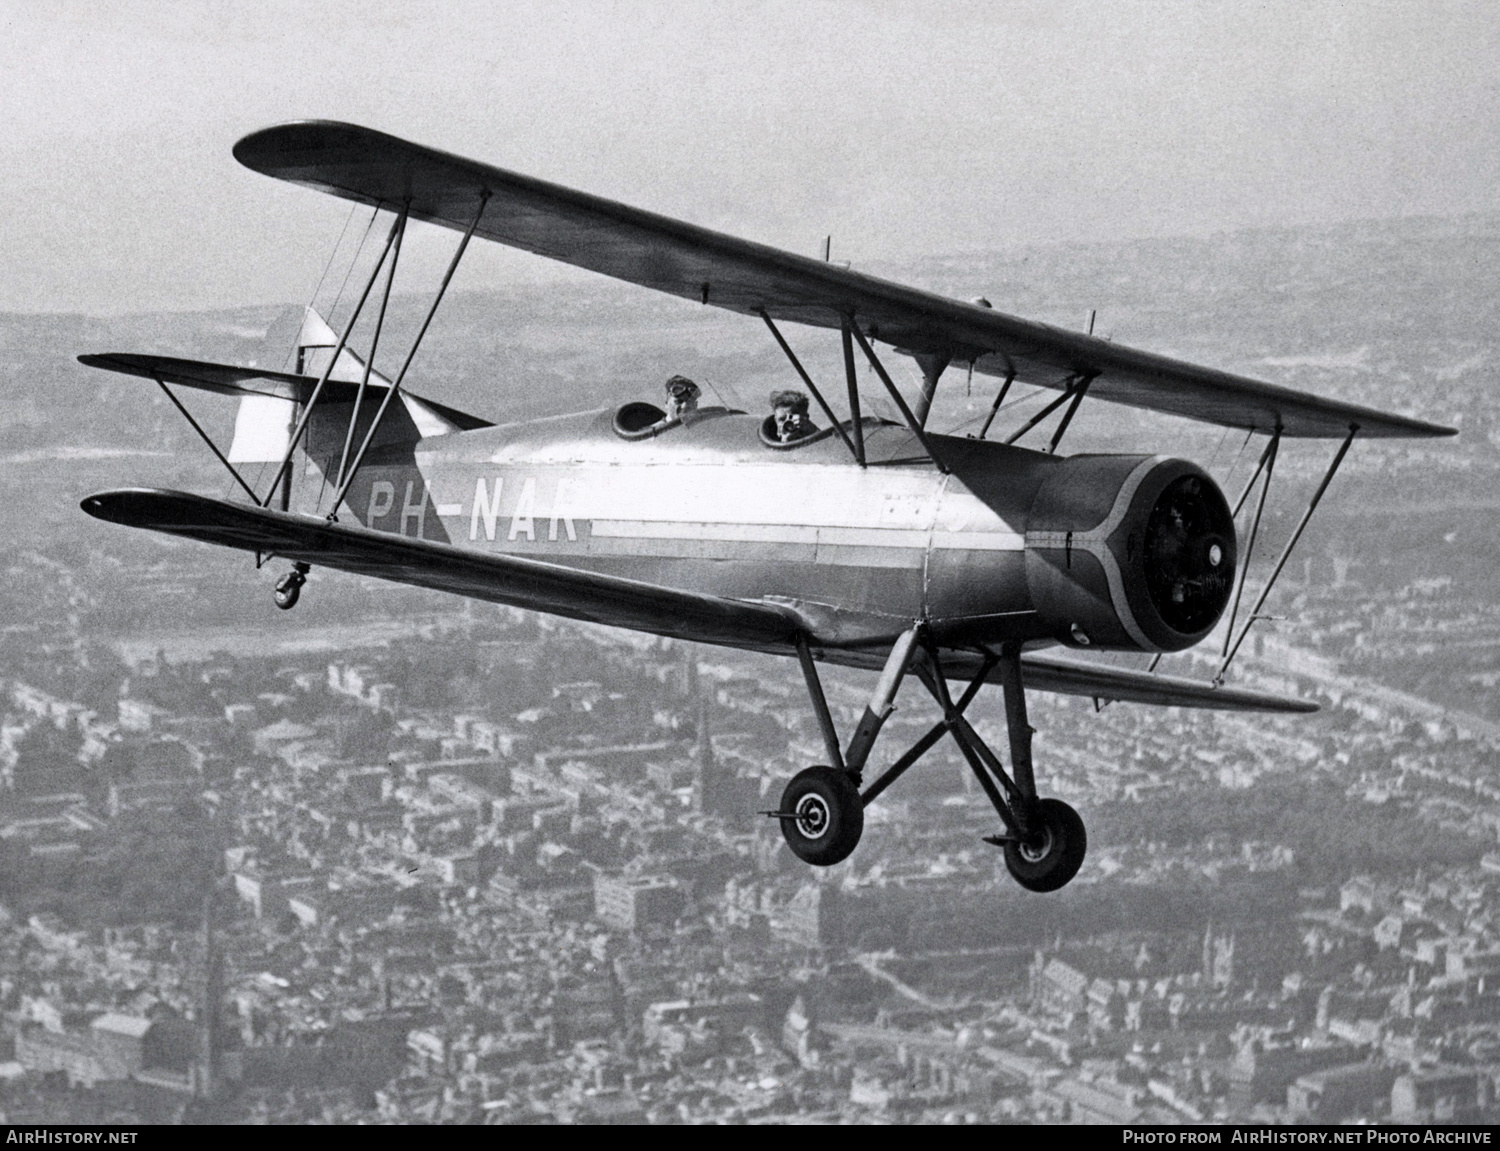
top-left (0, 0), bottom-right (1500, 311)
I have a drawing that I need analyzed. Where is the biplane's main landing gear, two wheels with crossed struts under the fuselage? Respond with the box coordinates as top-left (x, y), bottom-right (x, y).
top-left (767, 626), bottom-right (1088, 891)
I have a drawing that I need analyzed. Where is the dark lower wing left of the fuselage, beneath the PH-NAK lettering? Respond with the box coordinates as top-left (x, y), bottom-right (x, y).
top-left (83, 488), bottom-right (798, 647)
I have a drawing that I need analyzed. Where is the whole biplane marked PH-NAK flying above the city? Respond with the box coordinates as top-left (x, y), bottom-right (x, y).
top-left (80, 122), bottom-right (1454, 891)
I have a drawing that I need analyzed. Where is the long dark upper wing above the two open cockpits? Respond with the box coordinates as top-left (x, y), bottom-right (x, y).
top-left (234, 120), bottom-right (1454, 438)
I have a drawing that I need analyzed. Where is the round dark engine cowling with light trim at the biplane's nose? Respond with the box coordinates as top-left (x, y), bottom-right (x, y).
top-left (1026, 456), bottom-right (1238, 651)
